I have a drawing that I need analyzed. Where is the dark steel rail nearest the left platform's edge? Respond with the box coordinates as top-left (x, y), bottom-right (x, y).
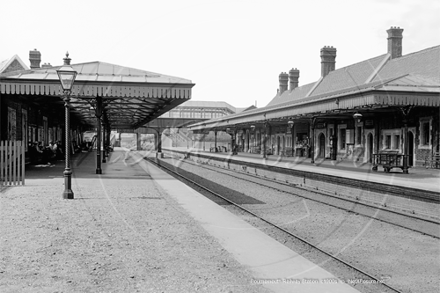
top-left (144, 155), bottom-right (410, 293)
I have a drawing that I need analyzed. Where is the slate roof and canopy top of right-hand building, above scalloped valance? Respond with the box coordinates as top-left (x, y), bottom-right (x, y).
top-left (193, 46), bottom-right (440, 128)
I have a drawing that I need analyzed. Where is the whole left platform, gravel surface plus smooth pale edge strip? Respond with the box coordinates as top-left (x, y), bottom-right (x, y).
top-left (0, 148), bottom-right (358, 293)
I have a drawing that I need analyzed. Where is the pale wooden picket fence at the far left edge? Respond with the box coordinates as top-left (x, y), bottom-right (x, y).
top-left (0, 141), bottom-right (25, 186)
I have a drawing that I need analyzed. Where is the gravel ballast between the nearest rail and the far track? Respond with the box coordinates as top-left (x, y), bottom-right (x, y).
top-left (159, 159), bottom-right (440, 292)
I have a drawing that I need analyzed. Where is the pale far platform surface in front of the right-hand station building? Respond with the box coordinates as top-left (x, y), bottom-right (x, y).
top-left (169, 148), bottom-right (440, 195)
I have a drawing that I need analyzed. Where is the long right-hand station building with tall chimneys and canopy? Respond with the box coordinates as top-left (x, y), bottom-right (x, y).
top-left (189, 27), bottom-right (440, 167)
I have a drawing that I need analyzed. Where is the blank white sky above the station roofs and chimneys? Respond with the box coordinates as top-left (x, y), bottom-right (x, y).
top-left (0, 0), bottom-right (440, 107)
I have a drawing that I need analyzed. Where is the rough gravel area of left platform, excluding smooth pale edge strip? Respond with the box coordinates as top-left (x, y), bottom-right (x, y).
top-left (0, 153), bottom-right (268, 293)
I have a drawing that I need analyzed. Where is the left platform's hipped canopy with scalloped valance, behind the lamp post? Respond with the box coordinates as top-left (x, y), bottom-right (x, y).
top-left (0, 61), bottom-right (194, 130)
